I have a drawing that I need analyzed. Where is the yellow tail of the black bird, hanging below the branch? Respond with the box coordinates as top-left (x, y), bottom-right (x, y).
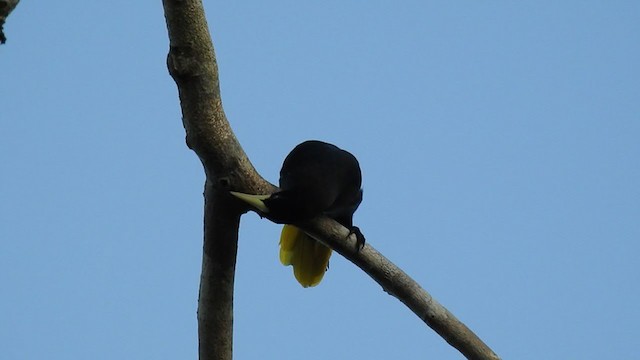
top-left (280, 225), bottom-right (331, 287)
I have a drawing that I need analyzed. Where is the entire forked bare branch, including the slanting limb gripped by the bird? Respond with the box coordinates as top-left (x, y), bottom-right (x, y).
top-left (163, 0), bottom-right (498, 360)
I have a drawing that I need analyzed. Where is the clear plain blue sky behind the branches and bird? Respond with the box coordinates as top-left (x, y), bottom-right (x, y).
top-left (0, 0), bottom-right (640, 360)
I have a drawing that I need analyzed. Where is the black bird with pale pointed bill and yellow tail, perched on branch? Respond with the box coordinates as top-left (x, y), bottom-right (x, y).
top-left (230, 140), bottom-right (365, 288)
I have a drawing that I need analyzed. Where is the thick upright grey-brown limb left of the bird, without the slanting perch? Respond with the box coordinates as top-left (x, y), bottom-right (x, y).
top-left (163, 0), bottom-right (273, 360)
